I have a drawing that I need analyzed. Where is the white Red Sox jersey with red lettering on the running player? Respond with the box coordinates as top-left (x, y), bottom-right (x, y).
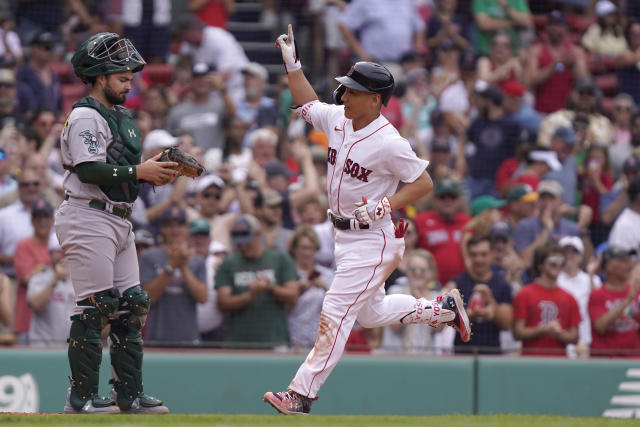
top-left (300, 101), bottom-right (429, 222)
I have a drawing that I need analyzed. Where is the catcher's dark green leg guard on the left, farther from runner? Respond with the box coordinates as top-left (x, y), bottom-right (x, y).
top-left (67, 289), bottom-right (118, 410)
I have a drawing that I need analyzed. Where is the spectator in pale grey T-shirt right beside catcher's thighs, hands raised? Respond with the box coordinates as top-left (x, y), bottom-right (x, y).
top-left (27, 239), bottom-right (76, 346)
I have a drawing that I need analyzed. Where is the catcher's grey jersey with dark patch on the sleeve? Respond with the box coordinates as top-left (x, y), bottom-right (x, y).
top-left (60, 107), bottom-right (138, 207)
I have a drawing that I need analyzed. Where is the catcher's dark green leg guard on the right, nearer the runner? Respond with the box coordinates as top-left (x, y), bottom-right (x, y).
top-left (109, 286), bottom-right (151, 409)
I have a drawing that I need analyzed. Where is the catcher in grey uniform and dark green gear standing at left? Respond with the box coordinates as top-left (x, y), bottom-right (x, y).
top-left (55, 33), bottom-right (177, 414)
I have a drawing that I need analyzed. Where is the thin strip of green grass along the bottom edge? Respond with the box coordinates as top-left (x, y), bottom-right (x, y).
top-left (0, 414), bottom-right (638, 427)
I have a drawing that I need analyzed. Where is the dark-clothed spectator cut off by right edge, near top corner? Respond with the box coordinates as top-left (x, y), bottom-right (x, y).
top-left (618, 20), bottom-right (640, 105)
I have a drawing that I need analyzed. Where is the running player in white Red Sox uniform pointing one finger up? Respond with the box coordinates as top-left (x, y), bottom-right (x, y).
top-left (264, 25), bottom-right (470, 414)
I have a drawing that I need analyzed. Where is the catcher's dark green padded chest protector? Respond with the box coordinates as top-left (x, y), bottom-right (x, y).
top-left (73, 96), bottom-right (142, 203)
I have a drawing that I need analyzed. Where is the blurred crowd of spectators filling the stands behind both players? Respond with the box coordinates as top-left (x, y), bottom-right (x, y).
top-left (0, 0), bottom-right (640, 358)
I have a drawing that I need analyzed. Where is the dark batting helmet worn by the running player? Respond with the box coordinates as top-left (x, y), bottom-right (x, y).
top-left (333, 61), bottom-right (394, 105)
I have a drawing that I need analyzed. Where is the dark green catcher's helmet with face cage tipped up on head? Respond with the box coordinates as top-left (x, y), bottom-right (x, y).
top-left (71, 32), bottom-right (146, 83)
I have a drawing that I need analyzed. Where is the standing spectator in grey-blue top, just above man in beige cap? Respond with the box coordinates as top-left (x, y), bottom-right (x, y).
top-left (546, 126), bottom-right (578, 206)
